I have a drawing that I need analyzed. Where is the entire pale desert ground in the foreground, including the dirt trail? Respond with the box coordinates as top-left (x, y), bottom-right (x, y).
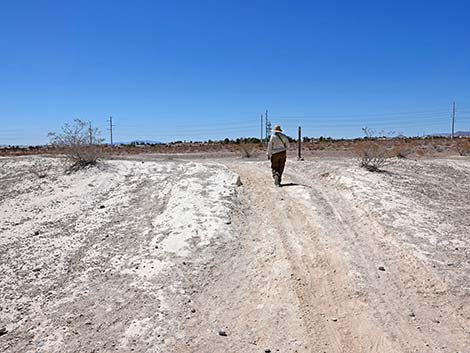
top-left (0, 155), bottom-right (470, 353)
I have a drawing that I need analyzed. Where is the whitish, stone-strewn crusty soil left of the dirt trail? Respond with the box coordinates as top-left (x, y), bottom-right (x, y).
top-left (0, 157), bottom-right (236, 352)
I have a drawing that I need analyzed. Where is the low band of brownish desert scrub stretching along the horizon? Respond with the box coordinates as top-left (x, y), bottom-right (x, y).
top-left (0, 138), bottom-right (470, 158)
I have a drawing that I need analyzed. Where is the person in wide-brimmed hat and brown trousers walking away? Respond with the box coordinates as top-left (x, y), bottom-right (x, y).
top-left (268, 125), bottom-right (289, 186)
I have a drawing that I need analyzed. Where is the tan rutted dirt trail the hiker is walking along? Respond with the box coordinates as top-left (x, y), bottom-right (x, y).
top-left (178, 162), bottom-right (470, 353)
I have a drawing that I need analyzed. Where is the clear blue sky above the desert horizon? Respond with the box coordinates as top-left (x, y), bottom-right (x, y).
top-left (0, 0), bottom-right (470, 144)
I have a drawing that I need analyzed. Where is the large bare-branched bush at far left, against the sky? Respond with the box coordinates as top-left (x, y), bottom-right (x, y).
top-left (48, 119), bottom-right (104, 172)
